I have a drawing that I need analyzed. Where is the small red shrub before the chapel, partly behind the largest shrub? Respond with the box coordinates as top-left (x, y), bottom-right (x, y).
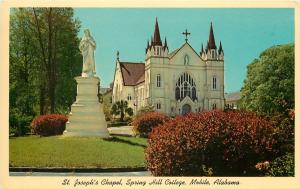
top-left (132, 112), bottom-right (169, 137)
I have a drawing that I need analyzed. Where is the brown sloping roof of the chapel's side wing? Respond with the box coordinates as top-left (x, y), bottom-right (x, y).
top-left (120, 62), bottom-right (145, 86)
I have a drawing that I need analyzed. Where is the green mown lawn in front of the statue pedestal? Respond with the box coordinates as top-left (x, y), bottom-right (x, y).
top-left (9, 136), bottom-right (147, 168)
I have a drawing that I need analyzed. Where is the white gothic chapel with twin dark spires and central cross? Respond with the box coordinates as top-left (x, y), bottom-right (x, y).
top-left (112, 20), bottom-right (225, 116)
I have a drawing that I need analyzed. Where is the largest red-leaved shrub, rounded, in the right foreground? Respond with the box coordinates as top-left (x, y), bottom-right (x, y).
top-left (145, 111), bottom-right (275, 176)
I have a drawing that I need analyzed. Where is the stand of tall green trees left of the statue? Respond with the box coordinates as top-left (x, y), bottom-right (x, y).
top-left (9, 8), bottom-right (82, 135)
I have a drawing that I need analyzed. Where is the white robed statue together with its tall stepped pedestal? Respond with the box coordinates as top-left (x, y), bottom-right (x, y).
top-left (64, 29), bottom-right (109, 138)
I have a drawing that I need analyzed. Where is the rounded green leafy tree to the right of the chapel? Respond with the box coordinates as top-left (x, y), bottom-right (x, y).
top-left (240, 44), bottom-right (295, 115)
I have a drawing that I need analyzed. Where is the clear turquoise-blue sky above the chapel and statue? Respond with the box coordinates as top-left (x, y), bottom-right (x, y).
top-left (75, 8), bottom-right (295, 92)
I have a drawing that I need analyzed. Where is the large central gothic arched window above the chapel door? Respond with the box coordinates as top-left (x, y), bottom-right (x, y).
top-left (175, 72), bottom-right (197, 100)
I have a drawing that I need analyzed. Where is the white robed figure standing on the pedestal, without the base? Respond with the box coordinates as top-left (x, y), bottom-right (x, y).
top-left (79, 29), bottom-right (96, 77)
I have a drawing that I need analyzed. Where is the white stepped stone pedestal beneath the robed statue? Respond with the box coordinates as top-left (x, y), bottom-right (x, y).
top-left (64, 77), bottom-right (109, 138)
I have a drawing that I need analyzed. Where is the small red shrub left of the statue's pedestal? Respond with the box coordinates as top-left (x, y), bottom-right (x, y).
top-left (31, 114), bottom-right (68, 136)
